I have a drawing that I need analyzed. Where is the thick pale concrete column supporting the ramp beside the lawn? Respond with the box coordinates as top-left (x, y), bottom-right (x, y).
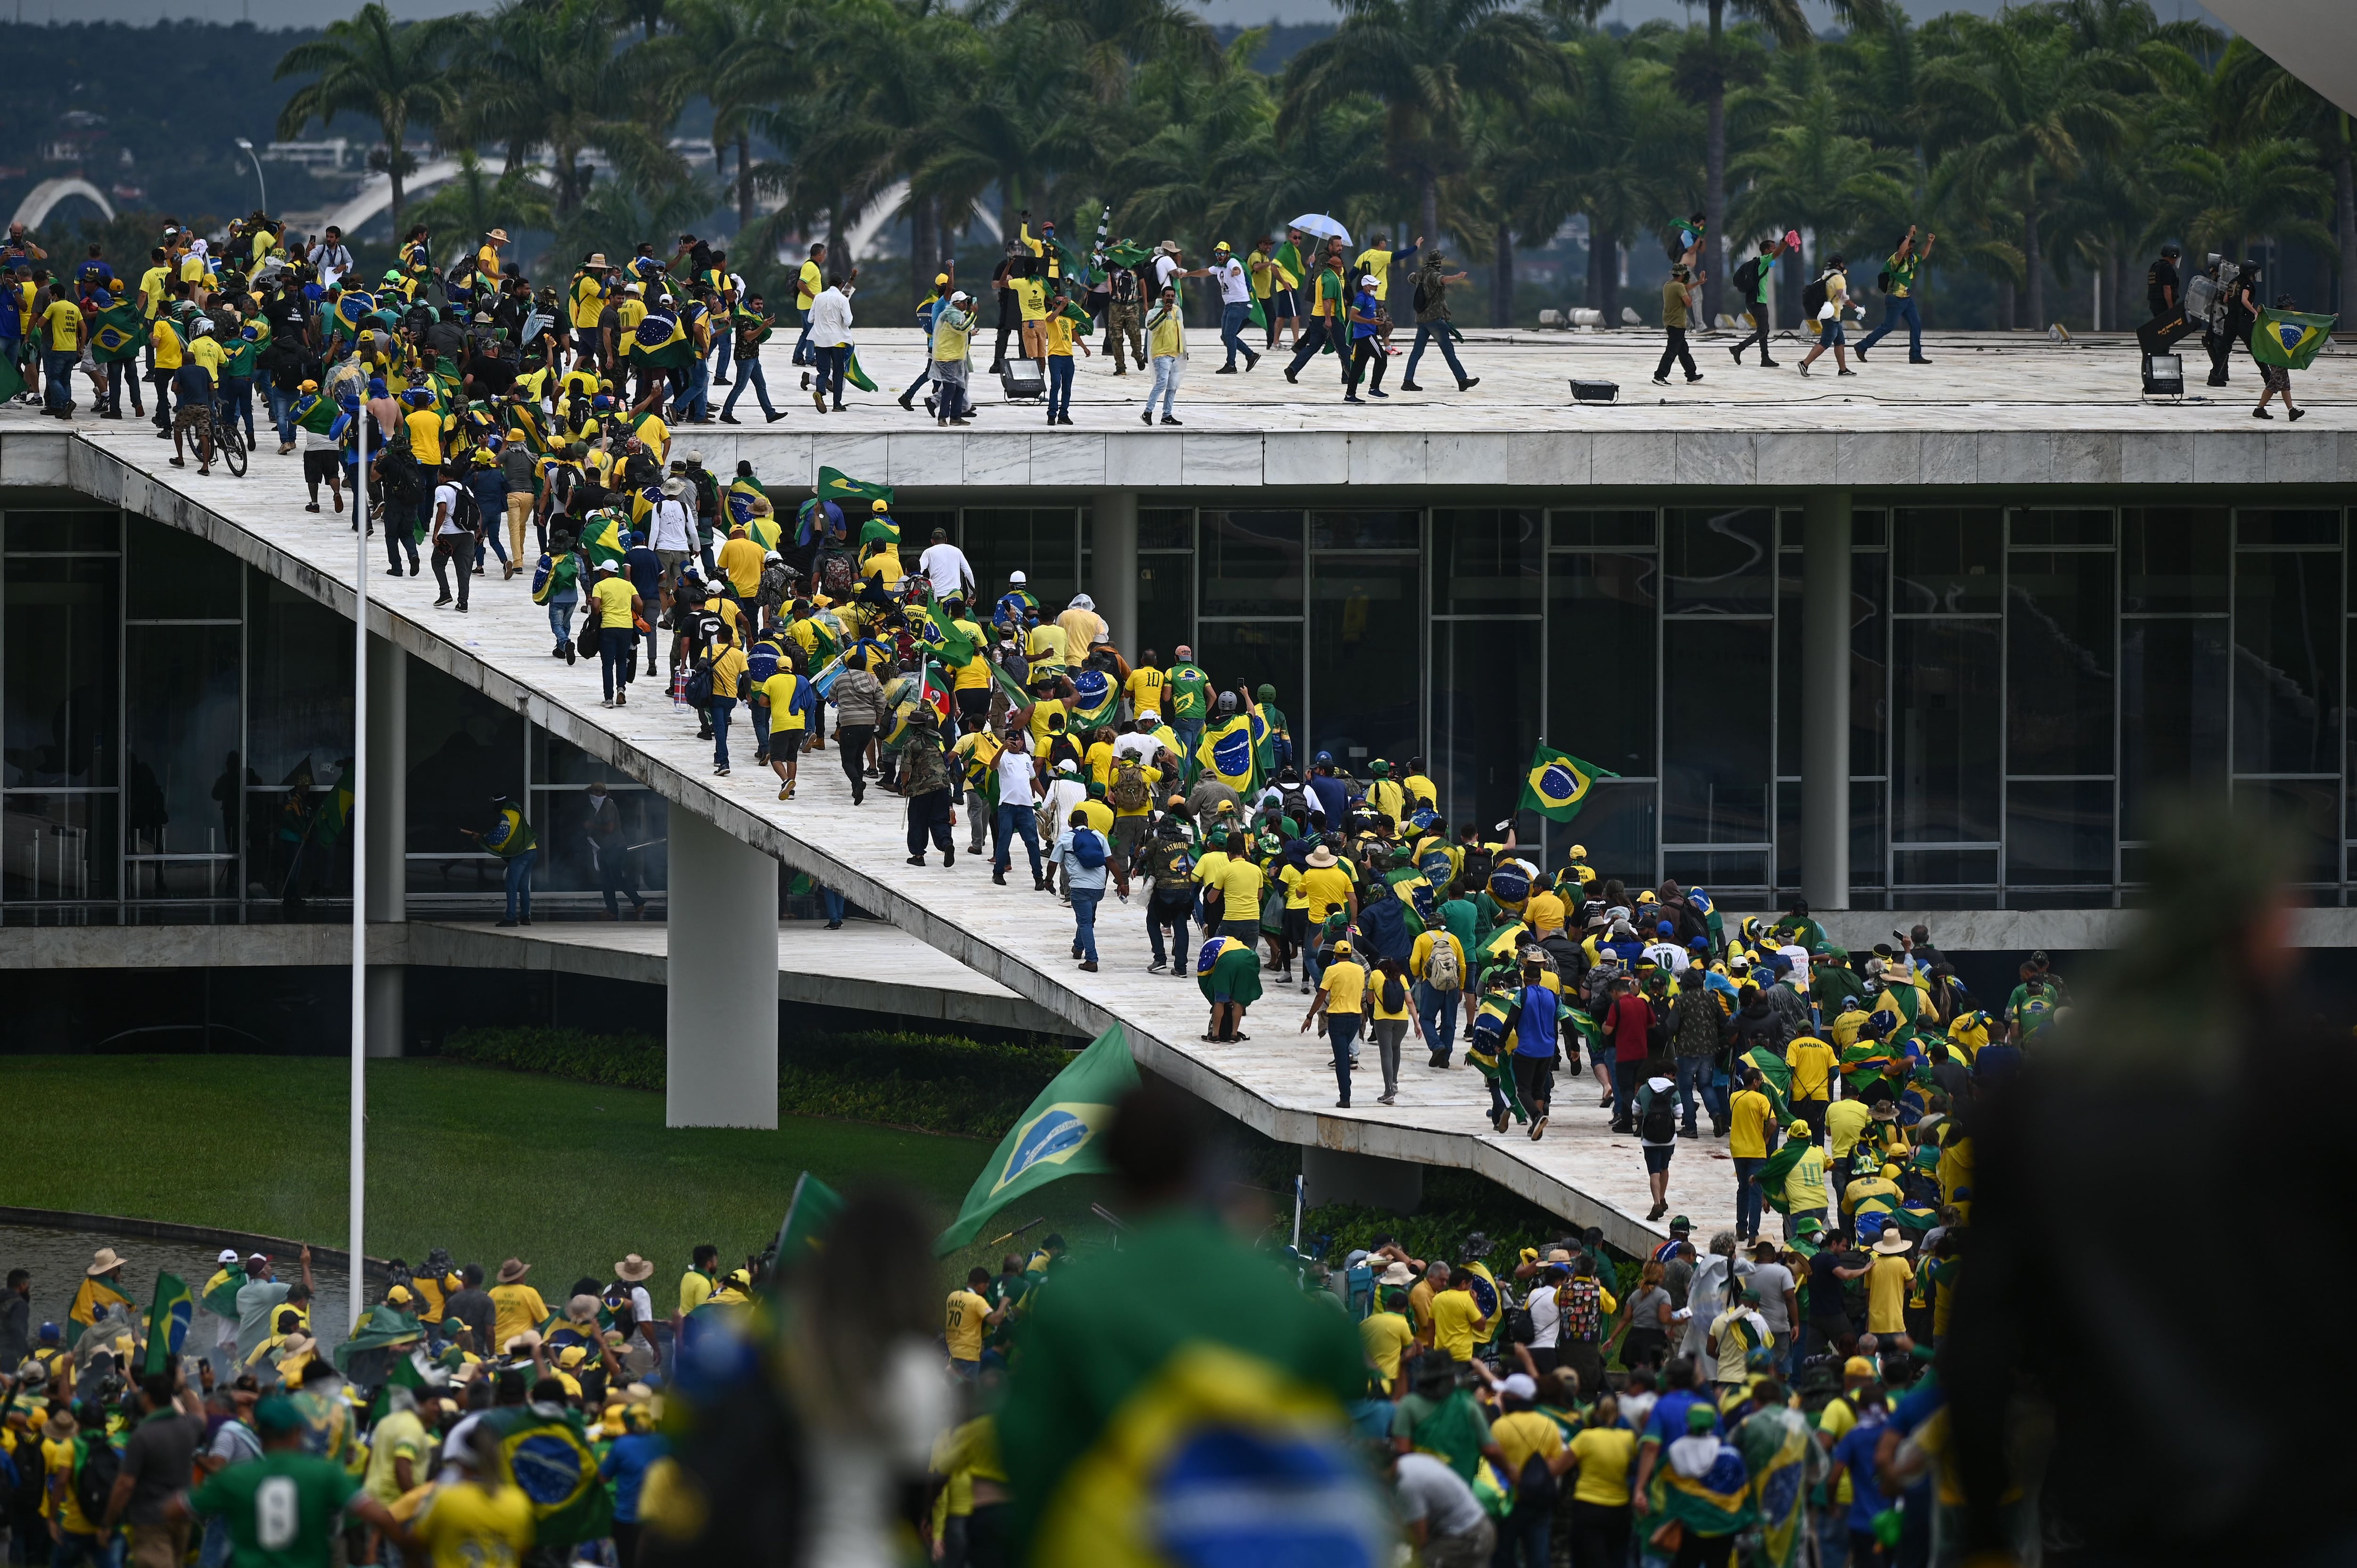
top-left (662, 806), bottom-right (778, 1127)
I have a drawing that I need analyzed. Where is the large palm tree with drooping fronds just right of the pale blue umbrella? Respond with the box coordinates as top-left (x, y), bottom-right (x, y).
top-left (1277, 0), bottom-right (1563, 236)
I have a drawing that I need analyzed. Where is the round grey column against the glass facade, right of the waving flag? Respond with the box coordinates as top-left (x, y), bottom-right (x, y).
top-left (1801, 491), bottom-right (1850, 910)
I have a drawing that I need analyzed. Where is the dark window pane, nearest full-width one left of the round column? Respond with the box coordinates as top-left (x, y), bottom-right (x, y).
top-left (1662, 620), bottom-right (1770, 844)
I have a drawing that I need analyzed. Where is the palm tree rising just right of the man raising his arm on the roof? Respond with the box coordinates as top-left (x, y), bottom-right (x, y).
top-left (1923, 12), bottom-right (2140, 328)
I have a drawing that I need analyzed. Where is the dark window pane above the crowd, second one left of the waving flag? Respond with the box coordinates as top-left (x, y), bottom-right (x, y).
top-left (1310, 554), bottom-right (1424, 764)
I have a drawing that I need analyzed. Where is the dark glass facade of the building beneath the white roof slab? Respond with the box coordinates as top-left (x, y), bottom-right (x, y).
top-left (0, 498), bottom-right (2357, 922)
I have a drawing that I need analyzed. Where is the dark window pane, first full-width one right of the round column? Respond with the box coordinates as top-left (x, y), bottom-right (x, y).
top-left (1890, 620), bottom-right (2003, 844)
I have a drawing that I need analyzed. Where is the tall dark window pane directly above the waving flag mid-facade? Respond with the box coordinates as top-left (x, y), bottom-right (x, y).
top-left (1546, 554), bottom-right (1657, 778)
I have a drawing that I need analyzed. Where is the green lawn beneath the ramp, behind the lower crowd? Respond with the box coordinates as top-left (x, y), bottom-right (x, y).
top-left (0, 1056), bottom-right (1103, 1306)
